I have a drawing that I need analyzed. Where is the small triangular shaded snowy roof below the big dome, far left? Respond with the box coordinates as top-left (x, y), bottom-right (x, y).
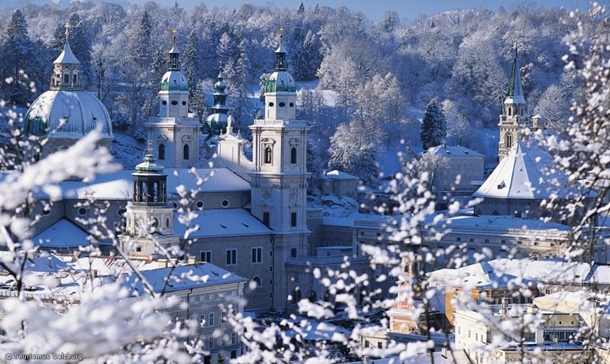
top-left (32, 218), bottom-right (90, 249)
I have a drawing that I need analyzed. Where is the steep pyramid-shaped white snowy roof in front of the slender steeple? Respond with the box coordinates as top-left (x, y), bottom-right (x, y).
top-left (473, 141), bottom-right (575, 200)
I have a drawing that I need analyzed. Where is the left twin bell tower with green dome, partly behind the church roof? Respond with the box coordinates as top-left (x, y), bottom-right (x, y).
top-left (146, 30), bottom-right (201, 168)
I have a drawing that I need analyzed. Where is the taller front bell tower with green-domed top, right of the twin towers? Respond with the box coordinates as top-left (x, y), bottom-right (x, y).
top-left (249, 28), bottom-right (310, 309)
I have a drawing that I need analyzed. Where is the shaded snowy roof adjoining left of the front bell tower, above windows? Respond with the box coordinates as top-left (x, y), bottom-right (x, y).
top-left (174, 209), bottom-right (272, 238)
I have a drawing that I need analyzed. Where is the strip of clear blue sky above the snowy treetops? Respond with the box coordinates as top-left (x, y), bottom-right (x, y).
top-left (158, 0), bottom-right (610, 21)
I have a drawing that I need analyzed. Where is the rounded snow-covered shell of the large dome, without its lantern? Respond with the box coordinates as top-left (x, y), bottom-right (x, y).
top-left (24, 90), bottom-right (113, 139)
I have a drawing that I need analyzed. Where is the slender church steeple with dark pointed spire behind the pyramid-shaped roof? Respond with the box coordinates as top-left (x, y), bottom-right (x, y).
top-left (498, 42), bottom-right (531, 160)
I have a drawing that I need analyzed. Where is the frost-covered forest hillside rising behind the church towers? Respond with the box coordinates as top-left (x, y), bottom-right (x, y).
top-left (0, 2), bottom-right (601, 177)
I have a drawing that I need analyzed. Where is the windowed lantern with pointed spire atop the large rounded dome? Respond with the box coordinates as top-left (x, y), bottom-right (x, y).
top-left (50, 23), bottom-right (83, 91)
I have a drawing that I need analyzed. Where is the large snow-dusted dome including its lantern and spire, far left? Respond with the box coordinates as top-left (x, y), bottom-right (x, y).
top-left (24, 24), bottom-right (113, 154)
